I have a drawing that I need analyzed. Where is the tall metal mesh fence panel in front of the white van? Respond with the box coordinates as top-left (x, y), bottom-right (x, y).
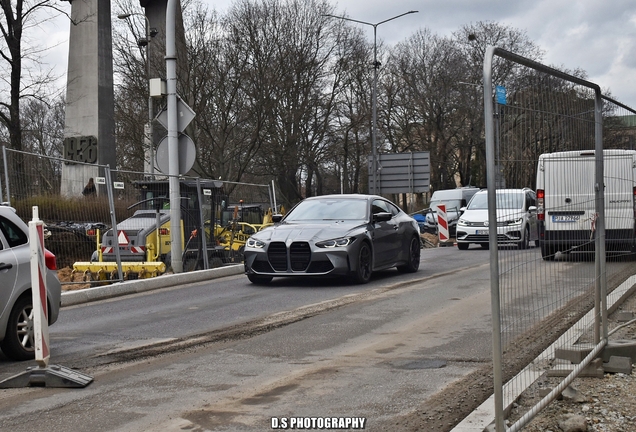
top-left (482, 45), bottom-right (636, 431)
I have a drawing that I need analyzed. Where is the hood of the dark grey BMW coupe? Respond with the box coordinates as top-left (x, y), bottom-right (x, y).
top-left (252, 221), bottom-right (365, 242)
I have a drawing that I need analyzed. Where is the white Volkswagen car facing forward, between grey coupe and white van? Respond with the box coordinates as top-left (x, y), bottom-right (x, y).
top-left (457, 188), bottom-right (539, 250)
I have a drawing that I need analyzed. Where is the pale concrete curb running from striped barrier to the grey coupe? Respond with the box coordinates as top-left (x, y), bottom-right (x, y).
top-left (61, 264), bottom-right (245, 307)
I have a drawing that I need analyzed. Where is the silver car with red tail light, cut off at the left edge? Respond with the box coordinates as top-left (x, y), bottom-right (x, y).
top-left (0, 206), bottom-right (62, 360)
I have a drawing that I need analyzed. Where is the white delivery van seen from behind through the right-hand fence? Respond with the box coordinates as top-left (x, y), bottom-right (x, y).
top-left (537, 149), bottom-right (636, 260)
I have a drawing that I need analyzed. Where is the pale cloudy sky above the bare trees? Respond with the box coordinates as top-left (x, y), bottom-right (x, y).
top-left (42, 0), bottom-right (636, 109)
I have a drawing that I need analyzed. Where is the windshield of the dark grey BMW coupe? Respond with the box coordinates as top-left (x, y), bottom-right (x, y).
top-left (285, 198), bottom-right (367, 222)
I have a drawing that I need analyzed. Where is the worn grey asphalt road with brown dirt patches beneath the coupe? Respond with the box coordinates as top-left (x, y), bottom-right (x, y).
top-left (0, 248), bottom-right (632, 432)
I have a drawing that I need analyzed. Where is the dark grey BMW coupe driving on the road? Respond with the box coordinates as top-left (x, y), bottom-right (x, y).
top-left (245, 194), bottom-right (420, 284)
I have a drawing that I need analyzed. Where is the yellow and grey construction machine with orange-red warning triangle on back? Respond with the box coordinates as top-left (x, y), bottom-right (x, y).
top-left (73, 180), bottom-right (233, 281)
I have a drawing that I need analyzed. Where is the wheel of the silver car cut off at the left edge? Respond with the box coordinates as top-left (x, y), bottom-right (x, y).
top-left (0, 297), bottom-right (35, 361)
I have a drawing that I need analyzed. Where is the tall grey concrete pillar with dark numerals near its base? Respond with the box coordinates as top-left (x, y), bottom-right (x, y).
top-left (61, 0), bottom-right (116, 197)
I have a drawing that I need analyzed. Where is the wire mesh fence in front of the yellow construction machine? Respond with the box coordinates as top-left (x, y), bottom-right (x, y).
top-left (0, 148), bottom-right (274, 289)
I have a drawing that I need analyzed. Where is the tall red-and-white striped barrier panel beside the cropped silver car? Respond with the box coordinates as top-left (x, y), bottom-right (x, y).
top-left (29, 206), bottom-right (50, 367)
